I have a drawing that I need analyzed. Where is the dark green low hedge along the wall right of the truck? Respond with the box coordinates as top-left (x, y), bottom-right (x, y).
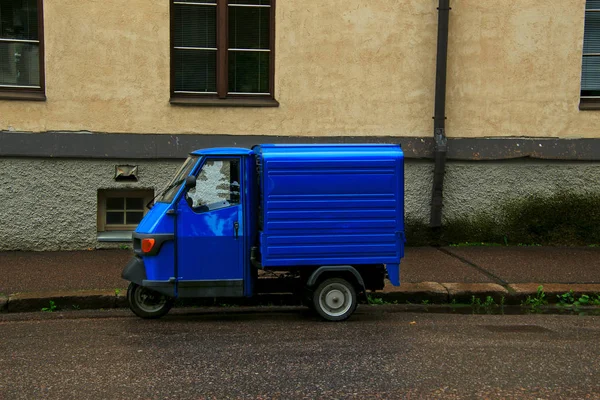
top-left (405, 191), bottom-right (600, 248)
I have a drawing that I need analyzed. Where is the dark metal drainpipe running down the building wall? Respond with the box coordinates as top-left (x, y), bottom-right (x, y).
top-left (429, 0), bottom-right (450, 228)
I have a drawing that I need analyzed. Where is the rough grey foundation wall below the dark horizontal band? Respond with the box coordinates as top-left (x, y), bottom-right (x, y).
top-left (0, 158), bottom-right (600, 251)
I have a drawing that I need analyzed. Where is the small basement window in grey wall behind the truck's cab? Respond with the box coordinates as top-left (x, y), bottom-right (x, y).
top-left (98, 189), bottom-right (154, 242)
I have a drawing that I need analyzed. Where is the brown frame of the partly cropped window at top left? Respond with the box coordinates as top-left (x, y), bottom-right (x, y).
top-left (0, 0), bottom-right (46, 101)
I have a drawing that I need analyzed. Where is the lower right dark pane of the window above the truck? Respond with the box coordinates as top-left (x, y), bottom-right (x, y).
top-left (229, 51), bottom-right (269, 93)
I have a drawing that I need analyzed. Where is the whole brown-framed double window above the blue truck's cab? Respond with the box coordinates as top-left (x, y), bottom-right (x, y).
top-left (171, 0), bottom-right (278, 106)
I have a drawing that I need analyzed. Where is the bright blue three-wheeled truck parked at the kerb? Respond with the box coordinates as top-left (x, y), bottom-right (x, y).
top-left (122, 145), bottom-right (405, 321)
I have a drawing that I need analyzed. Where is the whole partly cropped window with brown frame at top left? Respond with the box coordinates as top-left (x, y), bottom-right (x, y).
top-left (0, 0), bottom-right (46, 100)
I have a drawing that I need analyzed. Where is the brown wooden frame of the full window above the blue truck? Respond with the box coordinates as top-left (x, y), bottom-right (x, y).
top-left (169, 0), bottom-right (279, 107)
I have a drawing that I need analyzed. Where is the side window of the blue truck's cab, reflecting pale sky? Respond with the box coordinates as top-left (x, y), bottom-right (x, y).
top-left (185, 160), bottom-right (240, 212)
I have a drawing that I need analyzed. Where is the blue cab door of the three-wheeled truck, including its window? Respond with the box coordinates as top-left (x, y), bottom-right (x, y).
top-left (177, 157), bottom-right (244, 297)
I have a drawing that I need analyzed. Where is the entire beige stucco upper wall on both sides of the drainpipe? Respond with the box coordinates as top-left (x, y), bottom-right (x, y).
top-left (0, 0), bottom-right (600, 137)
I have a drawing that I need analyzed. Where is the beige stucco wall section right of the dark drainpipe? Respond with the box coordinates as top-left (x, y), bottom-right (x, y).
top-left (447, 0), bottom-right (600, 138)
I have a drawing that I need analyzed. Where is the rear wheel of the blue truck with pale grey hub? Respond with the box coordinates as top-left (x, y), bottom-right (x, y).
top-left (312, 278), bottom-right (358, 321)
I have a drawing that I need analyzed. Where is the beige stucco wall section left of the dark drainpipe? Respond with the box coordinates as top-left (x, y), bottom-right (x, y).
top-left (0, 0), bottom-right (437, 136)
